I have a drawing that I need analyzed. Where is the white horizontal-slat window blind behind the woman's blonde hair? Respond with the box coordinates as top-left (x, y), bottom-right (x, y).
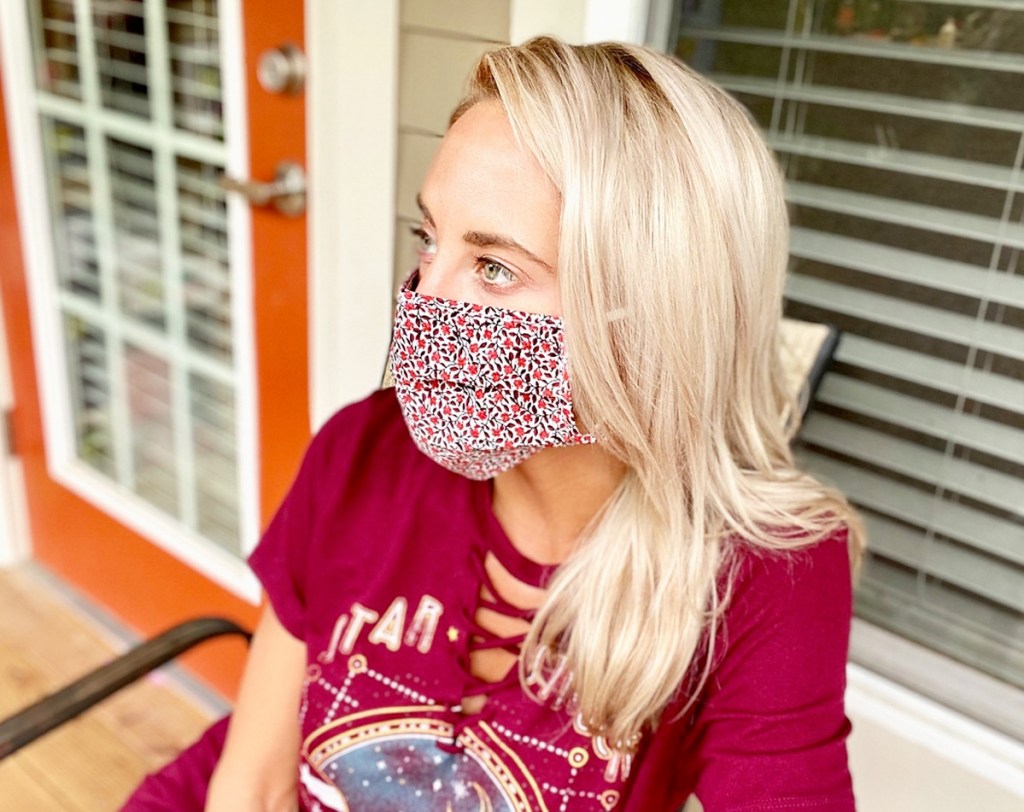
top-left (672, 0), bottom-right (1024, 735)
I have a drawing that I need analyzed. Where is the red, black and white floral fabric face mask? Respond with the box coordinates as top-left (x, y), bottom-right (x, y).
top-left (391, 288), bottom-right (594, 479)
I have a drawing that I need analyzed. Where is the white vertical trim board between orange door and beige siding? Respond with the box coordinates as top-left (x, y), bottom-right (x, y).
top-left (306, 0), bottom-right (398, 429)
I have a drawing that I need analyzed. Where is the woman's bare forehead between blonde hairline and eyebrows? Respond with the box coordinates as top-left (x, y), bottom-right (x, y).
top-left (423, 100), bottom-right (561, 241)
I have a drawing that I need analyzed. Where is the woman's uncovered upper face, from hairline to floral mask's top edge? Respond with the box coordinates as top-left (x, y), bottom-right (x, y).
top-left (416, 101), bottom-right (561, 315)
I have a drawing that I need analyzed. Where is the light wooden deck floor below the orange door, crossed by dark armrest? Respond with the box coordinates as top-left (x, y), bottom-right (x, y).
top-left (0, 565), bottom-right (218, 812)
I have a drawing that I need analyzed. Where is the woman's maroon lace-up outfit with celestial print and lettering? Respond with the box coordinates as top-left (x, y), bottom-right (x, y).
top-left (121, 390), bottom-right (853, 812)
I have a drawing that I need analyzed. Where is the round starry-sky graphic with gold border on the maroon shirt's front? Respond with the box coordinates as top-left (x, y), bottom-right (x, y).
top-left (300, 706), bottom-right (544, 812)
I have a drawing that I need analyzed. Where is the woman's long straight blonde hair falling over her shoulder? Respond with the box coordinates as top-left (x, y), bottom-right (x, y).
top-left (453, 38), bottom-right (862, 751)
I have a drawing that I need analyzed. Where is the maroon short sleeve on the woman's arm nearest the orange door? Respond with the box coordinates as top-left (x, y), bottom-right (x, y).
top-left (249, 411), bottom-right (328, 640)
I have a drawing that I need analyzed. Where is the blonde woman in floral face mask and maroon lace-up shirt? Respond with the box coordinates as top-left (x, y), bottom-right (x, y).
top-left (128, 38), bottom-right (860, 812)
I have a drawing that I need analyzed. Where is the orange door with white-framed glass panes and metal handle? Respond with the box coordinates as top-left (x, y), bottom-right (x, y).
top-left (0, 0), bottom-right (309, 693)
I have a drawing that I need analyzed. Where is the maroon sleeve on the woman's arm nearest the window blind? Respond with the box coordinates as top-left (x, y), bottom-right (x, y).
top-left (690, 530), bottom-right (854, 812)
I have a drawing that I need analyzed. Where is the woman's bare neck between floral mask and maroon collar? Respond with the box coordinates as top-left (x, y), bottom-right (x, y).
top-left (493, 443), bottom-right (626, 564)
